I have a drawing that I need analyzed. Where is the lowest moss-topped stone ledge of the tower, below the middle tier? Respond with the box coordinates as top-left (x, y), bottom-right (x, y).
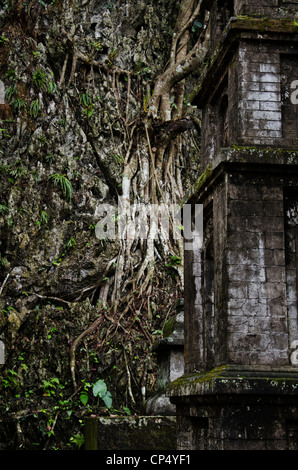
top-left (166, 365), bottom-right (298, 398)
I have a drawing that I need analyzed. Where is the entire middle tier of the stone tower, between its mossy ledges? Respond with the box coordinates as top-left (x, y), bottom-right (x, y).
top-left (185, 164), bottom-right (298, 372)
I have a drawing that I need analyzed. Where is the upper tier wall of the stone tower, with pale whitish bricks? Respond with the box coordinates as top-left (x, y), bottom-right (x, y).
top-left (202, 40), bottom-right (298, 168)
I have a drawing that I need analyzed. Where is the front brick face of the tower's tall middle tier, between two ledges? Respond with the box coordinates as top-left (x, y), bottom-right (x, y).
top-left (227, 175), bottom-right (289, 366)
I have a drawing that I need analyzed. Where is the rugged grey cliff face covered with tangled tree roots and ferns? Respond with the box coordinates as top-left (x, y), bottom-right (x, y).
top-left (0, 0), bottom-right (203, 448)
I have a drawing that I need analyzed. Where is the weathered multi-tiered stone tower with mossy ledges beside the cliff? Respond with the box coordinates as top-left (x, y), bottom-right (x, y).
top-left (167, 0), bottom-right (298, 450)
